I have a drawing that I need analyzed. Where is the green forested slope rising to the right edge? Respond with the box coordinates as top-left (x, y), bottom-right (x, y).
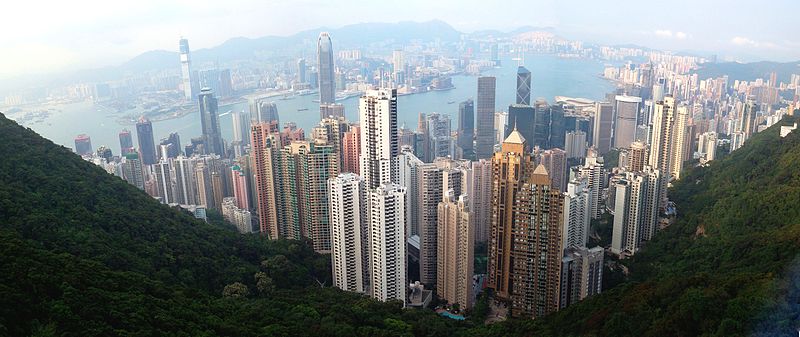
top-left (484, 114), bottom-right (800, 336)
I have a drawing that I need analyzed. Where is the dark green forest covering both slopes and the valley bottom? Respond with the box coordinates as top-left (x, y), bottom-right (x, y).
top-left (0, 111), bottom-right (800, 336)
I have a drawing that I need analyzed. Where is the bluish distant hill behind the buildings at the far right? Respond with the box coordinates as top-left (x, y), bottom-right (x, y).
top-left (696, 61), bottom-right (800, 82)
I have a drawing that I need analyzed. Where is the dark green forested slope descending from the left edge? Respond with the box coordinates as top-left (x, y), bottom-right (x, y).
top-left (0, 115), bottom-right (462, 336)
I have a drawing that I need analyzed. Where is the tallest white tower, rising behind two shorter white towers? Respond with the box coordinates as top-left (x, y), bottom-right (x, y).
top-left (358, 89), bottom-right (399, 190)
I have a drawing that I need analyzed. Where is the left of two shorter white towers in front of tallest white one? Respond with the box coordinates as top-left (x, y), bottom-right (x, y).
top-left (328, 173), bottom-right (370, 293)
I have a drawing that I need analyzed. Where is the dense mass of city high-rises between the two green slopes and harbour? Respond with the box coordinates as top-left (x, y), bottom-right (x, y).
top-left (62, 28), bottom-right (800, 319)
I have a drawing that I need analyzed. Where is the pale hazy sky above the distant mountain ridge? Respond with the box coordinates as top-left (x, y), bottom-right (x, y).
top-left (0, 0), bottom-right (800, 77)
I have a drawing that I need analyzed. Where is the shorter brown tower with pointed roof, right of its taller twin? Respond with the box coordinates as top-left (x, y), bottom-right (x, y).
top-left (509, 165), bottom-right (564, 318)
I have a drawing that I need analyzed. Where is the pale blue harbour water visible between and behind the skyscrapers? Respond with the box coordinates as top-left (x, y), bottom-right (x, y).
top-left (9, 55), bottom-right (614, 154)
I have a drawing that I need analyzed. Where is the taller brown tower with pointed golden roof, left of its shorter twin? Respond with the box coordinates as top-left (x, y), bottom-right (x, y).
top-left (487, 129), bottom-right (533, 300)
